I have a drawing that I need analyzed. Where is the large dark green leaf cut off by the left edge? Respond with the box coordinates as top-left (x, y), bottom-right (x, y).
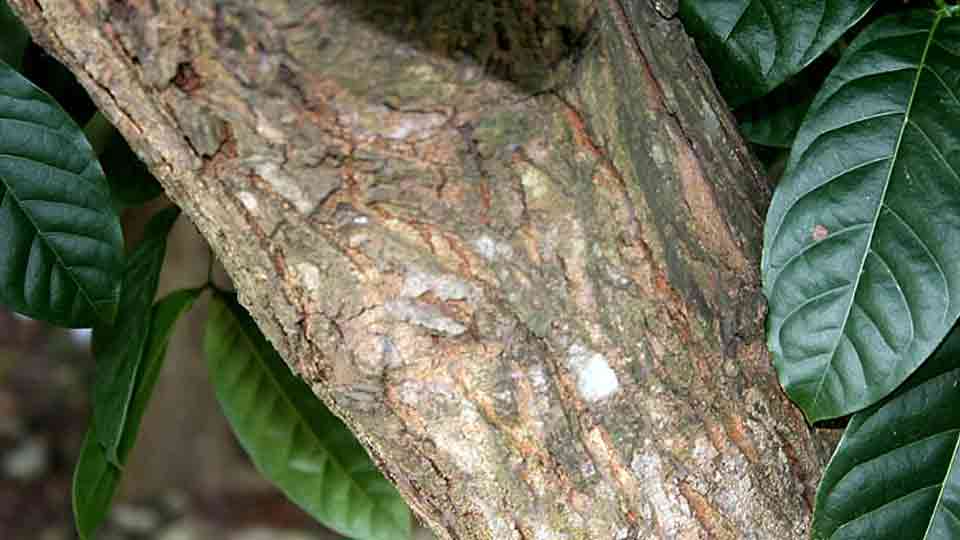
top-left (0, 62), bottom-right (123, 327)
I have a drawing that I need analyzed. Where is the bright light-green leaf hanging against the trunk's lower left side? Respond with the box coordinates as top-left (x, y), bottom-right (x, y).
top-left (204, 294), bottom-right (410, 540)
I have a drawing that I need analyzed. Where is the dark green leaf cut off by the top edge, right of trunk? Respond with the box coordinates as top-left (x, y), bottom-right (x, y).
top-left (680, 0), bottom-right (876, 107)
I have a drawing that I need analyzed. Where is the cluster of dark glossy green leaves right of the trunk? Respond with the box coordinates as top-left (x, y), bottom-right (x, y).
top-left (681, 0), bottom-right (960, 540)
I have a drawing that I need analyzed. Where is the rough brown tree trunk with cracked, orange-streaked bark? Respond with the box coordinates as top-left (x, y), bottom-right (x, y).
top-left (12, 0), bottom-right (840, 540)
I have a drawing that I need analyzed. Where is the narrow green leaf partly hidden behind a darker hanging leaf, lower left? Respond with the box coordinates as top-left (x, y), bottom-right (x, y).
top-left (73, 289), bottom-right (203, 540)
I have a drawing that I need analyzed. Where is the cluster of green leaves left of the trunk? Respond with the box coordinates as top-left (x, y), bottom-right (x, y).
top-left (0, 4), bottom-right (411, 540)
